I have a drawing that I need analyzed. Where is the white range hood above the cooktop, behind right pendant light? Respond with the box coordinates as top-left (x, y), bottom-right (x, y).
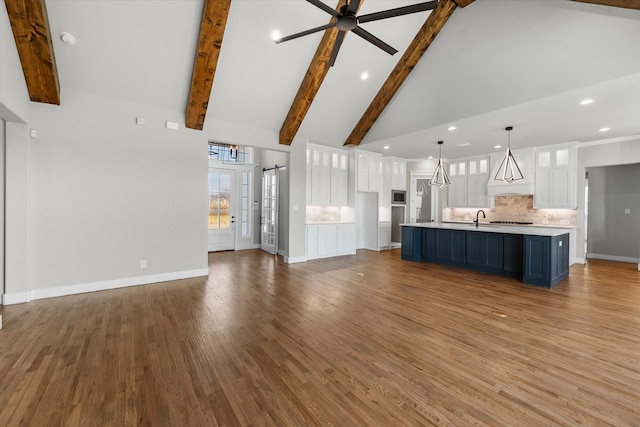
top-left (487, 148), bottom-right (534, 196)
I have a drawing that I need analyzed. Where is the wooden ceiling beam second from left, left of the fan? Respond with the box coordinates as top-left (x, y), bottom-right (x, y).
top-left (185, 0), bottom-right (231, 130)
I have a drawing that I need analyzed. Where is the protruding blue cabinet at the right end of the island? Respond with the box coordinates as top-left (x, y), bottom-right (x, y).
top-left (522, 234), bottom-right (569, 288)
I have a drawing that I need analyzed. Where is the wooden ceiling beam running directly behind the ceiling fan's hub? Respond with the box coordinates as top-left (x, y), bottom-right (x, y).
top-left (279, 0), bottom-right (350, 145)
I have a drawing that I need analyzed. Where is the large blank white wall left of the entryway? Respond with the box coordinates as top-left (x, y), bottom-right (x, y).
top-left (24, 92), bottom-right (208, 298)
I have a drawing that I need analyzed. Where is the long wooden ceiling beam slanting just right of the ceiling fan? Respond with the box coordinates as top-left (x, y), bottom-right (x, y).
top-left (344, 0), bottom-right (457, 147)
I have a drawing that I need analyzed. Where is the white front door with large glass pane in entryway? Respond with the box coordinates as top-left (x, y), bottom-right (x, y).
top-left (209, 168), bottom-right (236, 252)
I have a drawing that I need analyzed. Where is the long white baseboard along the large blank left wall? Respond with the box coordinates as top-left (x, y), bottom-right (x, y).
top-left (3, 267), bottom-right (209, 305)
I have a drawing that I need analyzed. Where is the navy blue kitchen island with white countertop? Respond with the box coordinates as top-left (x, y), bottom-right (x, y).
top-left (402, 223), bottom-right (569, 288)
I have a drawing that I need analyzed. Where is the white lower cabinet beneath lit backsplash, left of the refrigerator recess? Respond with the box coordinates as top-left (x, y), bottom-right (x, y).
top-left (307, 223), bottom-right (356, 259)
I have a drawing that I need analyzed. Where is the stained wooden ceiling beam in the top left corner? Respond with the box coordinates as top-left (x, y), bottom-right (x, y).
top-left (4, 0), bottom-right (60, 105)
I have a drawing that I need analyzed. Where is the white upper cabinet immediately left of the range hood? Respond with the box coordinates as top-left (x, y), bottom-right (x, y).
top-left (448, 156), bottom-right (489, 208)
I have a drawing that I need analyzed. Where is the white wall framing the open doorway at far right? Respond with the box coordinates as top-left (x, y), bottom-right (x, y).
top-left (576, 137), bottom-right (640, 262)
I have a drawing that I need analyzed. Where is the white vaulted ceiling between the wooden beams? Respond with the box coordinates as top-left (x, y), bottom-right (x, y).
top-left (46, 0), bottom-right (640, 159)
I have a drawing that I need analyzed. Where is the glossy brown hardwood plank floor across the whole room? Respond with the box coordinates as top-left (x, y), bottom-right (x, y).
top-left (0, 250), bottom-right (640, 426)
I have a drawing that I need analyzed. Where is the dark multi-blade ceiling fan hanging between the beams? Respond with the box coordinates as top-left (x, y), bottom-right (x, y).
top-left (275, 0), bottom-right (438, 67)
